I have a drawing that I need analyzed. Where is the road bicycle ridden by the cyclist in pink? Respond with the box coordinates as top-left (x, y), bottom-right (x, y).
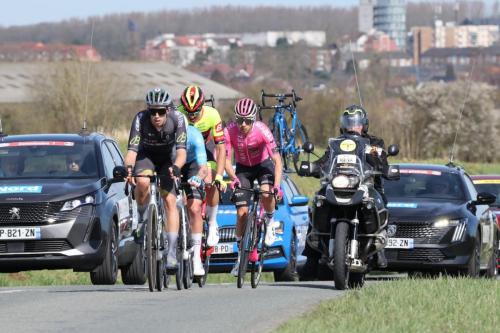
top-left (231, 186), bottom-right (277, 288)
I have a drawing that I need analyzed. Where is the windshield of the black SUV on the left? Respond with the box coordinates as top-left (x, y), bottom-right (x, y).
top-left (0, 141), bottom-right (98, 179)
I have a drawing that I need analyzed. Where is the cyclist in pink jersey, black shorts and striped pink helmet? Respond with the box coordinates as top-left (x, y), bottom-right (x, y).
top-left (224, 98), bottom-right (283, 276)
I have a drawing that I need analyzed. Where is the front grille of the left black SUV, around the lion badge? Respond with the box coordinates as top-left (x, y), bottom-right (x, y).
top-left (0, 201), bottom-right (92, 226)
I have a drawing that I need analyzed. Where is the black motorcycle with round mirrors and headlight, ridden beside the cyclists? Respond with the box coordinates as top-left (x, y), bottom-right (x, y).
top-left (300, 134), bottom-right (399, 290)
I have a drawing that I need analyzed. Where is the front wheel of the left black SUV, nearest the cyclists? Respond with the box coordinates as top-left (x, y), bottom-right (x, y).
top-left (90, 221), bottom-right (118, 285)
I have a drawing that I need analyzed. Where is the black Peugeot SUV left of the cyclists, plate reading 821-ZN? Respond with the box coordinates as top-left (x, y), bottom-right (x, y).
top-left (0, 133), bottom-right (145, 284)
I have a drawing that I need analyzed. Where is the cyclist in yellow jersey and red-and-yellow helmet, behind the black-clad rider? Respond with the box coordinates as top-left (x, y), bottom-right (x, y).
top-left (178, 86), bottom-right (226, 246)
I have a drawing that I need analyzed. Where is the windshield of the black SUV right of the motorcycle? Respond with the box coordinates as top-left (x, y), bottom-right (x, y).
top-left (384, 168), bottom-right (465, 201)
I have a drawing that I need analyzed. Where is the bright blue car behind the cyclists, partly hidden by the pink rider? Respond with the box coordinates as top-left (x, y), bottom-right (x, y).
top-left (209, 175), bottom-right (309, 281)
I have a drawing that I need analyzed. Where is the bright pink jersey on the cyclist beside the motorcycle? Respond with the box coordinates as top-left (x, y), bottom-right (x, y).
top-left (224, 121), bottom-right (276, 166)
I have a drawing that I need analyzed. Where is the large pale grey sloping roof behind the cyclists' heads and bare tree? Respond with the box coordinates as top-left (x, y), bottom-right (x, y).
top-left (0, 62), bottom-right (242, 103)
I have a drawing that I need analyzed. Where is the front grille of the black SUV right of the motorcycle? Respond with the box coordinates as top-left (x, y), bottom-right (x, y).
top-left (391, 222), bottom-right (450, 244)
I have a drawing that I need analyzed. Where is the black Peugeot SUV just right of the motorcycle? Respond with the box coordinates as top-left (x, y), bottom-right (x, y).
top-left (385, 164), bottom-right (498, 278)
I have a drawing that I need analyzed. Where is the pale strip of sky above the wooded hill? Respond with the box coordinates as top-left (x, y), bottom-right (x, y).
top-left (0, 0), bottom-right (494, 27)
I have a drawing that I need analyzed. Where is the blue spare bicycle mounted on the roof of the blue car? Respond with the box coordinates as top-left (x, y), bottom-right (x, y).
top-left (259, 89), bottom-right (308, 172)
